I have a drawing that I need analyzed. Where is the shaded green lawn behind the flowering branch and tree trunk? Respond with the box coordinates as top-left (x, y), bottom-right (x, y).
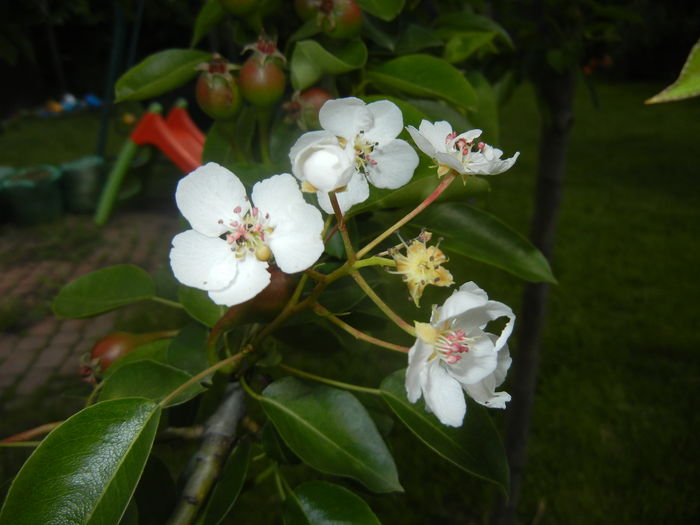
top-left (0, 84), bottom-right (700, 525)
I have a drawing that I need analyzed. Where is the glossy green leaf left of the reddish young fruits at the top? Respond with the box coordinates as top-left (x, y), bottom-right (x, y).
top-left (114, 49), bottom-right (211, 102)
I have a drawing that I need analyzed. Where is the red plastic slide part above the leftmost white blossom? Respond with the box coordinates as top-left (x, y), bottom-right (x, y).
top-left (131, 107), bottom-right (204, 173)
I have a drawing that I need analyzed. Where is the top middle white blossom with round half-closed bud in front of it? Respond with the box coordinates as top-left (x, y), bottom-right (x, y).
top-left (289, 97), bottom-right (418, 213)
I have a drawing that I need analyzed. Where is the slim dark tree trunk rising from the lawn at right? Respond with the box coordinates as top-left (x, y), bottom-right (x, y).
top-left (493, 70), bottom-right (575, 525)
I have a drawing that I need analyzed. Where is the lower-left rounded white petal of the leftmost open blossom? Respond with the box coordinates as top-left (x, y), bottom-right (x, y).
top-left (170, 230), bottom-right (238, 290)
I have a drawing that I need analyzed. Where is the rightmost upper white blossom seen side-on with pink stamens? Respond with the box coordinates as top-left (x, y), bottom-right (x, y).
top-left (406, 120), bottom-right (520, 176)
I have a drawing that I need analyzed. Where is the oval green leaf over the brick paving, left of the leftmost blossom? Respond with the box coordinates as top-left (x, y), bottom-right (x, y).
top-left (52, 264), bottom-right (155, 318)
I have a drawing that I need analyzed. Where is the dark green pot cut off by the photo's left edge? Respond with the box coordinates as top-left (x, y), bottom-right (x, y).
top-left (3, 164), bottom-right (63, 226)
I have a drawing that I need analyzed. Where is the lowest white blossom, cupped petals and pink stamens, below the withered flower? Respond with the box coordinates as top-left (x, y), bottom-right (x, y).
top-left (406, 282), bottom-right (515, 427)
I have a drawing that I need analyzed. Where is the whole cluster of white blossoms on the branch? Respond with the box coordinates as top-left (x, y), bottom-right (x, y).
top-left (170, 98), bottom-right (518, 426)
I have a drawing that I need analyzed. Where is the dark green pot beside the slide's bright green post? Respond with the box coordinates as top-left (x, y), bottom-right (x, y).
top-left (61, 156), bottom-right (104, 213)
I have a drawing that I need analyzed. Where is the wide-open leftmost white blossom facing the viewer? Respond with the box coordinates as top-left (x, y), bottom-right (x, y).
top-left (170, 162), bottom-right (323, 306)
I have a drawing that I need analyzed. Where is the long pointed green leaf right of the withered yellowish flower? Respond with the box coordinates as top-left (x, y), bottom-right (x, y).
top-left (408, 203), bottom-right (557, 283)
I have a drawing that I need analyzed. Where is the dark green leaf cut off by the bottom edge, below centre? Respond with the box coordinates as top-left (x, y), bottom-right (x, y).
top-left (283, 481), bottom-right (380, 525)
